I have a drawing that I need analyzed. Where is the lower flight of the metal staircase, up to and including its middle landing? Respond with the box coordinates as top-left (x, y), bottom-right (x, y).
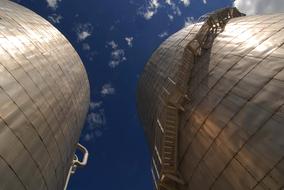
top-left (153, 83), bottom-right (184, 190)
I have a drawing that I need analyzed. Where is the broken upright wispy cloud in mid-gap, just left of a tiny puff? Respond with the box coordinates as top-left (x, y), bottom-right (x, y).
top-left (107, 41), bottom-right (126, 68)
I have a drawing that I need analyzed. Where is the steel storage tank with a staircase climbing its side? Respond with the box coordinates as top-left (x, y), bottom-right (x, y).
top-left (137, 8), bottom-right (284, 190)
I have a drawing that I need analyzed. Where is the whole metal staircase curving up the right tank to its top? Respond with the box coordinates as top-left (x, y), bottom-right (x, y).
top-left (152, 8), bottom-right (244, 190)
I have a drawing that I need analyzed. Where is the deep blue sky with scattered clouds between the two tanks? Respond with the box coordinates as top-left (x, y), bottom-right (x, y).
top-left (12, 0), bottom-right (283, 190)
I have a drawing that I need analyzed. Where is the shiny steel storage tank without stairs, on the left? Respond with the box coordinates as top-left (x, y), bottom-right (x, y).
top-left (0, 0), bottom-right (90, 190)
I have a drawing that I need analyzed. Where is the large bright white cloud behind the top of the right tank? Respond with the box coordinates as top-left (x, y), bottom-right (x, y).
top-left (234, 0), bottom-right (284, 15)
